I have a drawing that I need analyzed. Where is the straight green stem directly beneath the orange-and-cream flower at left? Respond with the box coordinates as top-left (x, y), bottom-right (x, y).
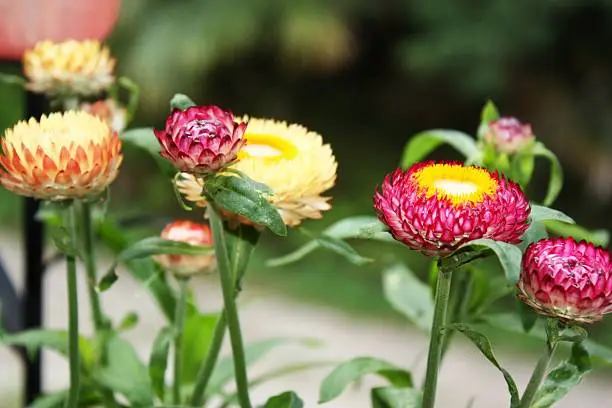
top-left (66, 203), bottom-right (81, 408)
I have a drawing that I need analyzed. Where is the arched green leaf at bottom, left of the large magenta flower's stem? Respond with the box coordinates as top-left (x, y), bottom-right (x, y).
top-left (319, 357), bottom-right (412, 404)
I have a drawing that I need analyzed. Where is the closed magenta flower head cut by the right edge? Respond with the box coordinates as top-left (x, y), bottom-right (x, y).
top-left (517, 237), bottom-right (612, 323)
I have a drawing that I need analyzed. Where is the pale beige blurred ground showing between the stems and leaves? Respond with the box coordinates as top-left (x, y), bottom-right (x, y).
top-left (0, 233), bottom-right (612, 408)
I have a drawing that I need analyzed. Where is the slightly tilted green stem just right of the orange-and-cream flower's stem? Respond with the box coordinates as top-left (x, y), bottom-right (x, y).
top-left (81, 201), bottom-right (105, 333)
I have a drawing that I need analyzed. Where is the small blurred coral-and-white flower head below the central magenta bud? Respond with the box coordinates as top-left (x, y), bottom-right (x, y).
top-left (154, 221), bottom-right (216, 277)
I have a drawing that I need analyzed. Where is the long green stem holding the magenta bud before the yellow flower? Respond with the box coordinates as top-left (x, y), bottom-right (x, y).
top-left (208, 204), bottom-right (251, 408)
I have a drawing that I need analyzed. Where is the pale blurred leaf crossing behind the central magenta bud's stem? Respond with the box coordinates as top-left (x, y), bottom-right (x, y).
top-left (207, 338), bottom-right (318, 395)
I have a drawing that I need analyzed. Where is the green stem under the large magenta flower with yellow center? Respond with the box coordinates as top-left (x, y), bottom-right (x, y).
top-left (422, 264), bottom-right (452, 408)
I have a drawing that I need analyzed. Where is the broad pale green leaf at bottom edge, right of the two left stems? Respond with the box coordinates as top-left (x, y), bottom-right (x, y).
top-left (92, 336), bottom-right (154, 407)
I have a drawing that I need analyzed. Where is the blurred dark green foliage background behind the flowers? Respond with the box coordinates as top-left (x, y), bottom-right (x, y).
top-left (0, 0), bottom-right (612, 406)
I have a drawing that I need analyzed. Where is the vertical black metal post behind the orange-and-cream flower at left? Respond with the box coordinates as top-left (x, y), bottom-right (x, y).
top-left (21, 93), bottom-right (45, 406)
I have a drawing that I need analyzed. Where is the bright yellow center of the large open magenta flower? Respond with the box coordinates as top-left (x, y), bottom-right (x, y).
top-left (413, 164), bottom-right (498, 205)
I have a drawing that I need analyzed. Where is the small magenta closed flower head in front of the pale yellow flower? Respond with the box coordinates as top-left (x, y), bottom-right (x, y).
top-left (155, 106), bottom-right (247, 174)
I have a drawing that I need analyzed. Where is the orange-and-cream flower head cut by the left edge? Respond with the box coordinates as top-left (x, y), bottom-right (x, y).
top-left (0, 111), bottom-right (123, 200)
